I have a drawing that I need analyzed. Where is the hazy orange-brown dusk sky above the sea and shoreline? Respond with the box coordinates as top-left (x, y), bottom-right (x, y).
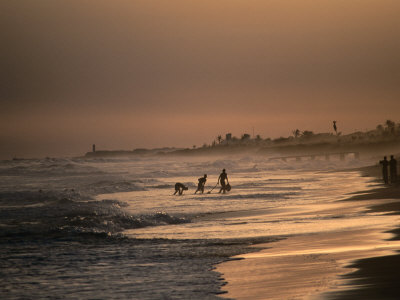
top-left (0, 0), bottom-right (400, 158)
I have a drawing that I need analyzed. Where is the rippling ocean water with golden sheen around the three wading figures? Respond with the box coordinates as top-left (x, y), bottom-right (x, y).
top-left (0, 155), bottom-right (386, 299)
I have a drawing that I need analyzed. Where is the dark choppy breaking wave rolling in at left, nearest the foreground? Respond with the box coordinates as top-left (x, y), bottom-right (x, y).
top-left (0, 191), bottom-right (190, 237)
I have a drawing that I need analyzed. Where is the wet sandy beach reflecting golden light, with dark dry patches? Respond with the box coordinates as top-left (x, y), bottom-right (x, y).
top-left (217, 167), bottom-right (400, 299)
